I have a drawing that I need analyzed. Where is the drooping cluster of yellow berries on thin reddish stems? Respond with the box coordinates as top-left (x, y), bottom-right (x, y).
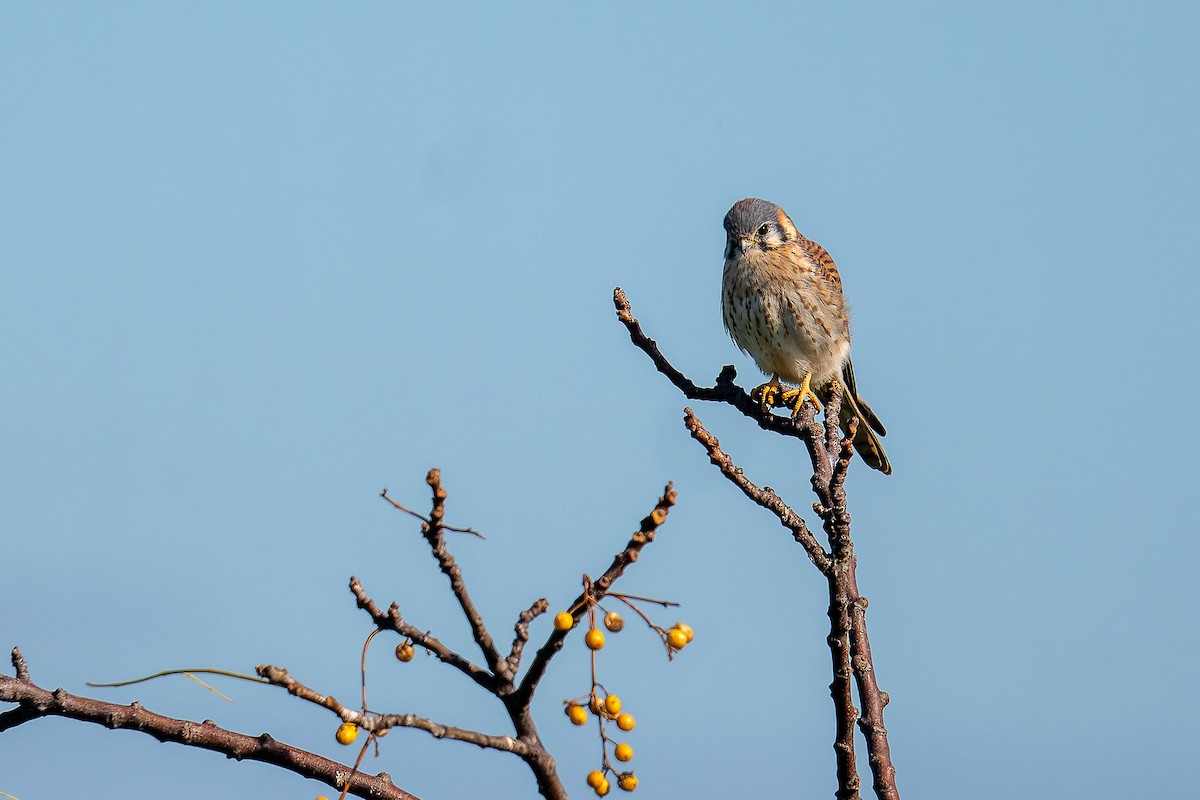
top-left (554, 594), bottom-right (695, 798)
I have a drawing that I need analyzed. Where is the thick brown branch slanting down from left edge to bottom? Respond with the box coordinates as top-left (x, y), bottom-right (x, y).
top-left (0, 649), bottom-right (418, 800)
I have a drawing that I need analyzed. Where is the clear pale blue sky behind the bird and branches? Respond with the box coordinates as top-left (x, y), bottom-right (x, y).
top-left (0, 2), bottom-right (1200, 800)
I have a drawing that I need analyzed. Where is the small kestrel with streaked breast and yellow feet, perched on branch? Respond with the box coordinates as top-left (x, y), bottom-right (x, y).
top-left (721, 198), bottom-right (892, 475)
